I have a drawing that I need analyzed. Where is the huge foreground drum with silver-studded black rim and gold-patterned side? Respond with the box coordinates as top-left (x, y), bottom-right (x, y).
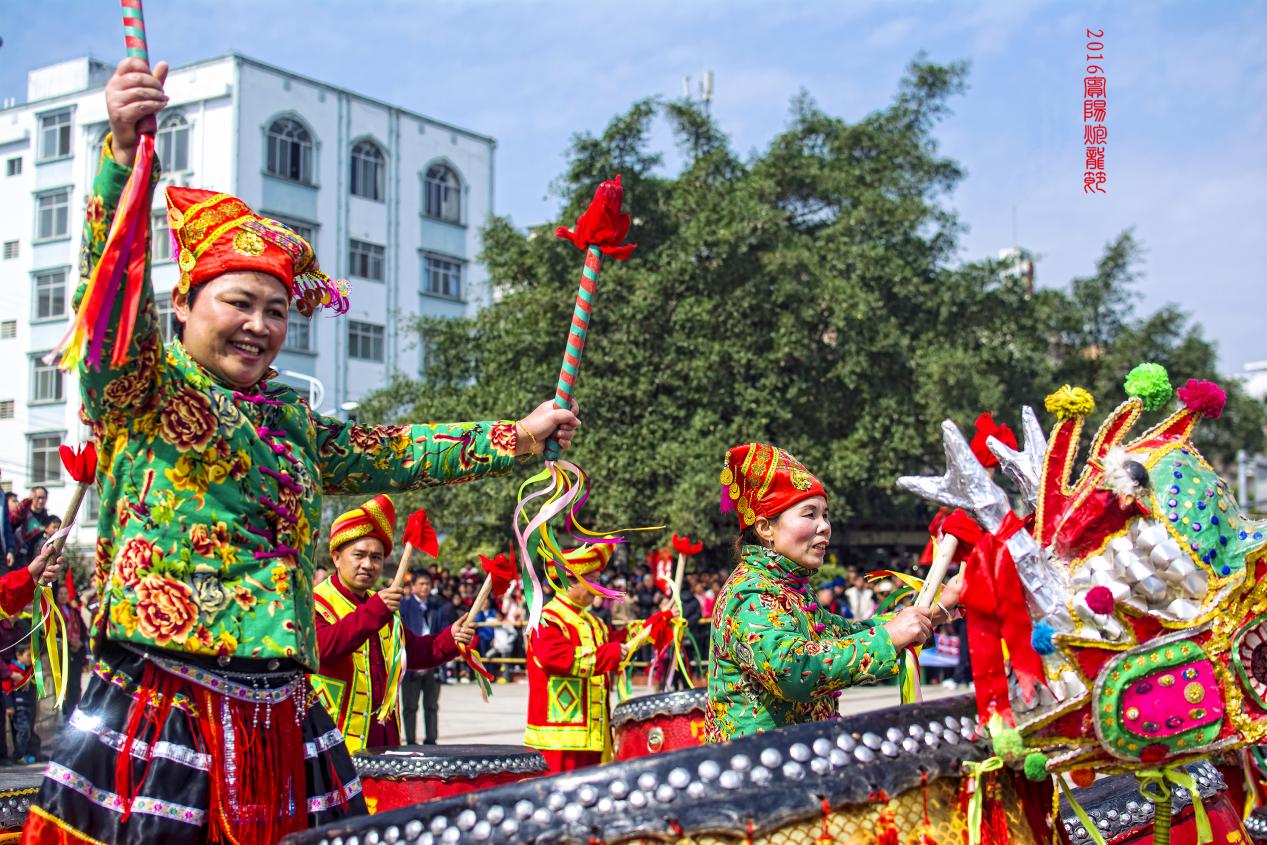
top-left (285, 697), bottom-right (1052, 845)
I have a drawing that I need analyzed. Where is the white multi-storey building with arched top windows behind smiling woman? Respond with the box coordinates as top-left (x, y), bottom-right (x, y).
top-left (0, 54), bottom-right (495, 543)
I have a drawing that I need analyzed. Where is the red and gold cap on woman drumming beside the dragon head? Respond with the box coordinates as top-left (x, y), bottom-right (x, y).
top-left (721, 443), bottom-right (827, 530)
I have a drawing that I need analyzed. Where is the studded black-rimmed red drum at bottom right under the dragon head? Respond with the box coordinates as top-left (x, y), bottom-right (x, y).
top-left (1060, 761), bottom-right (1253, 845)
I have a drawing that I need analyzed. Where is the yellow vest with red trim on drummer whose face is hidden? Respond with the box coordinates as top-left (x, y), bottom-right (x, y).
top-left (523, 595), bottom-right (612, 759)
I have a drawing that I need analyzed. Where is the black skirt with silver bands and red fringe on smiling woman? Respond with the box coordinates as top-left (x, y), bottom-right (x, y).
top-left (23, 644), bottom-right (365, 845)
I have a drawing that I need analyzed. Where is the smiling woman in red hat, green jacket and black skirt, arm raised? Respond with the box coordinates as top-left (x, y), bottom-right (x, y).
top-left (23, 60), bottom-right (578, 842)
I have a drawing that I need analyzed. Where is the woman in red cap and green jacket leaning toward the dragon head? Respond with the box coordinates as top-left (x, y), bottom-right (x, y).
top-left (704, 443), bottom-right (959, 742)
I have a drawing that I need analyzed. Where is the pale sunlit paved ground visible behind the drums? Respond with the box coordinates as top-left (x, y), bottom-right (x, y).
top-left (419, 683), bottom-right (963, 745)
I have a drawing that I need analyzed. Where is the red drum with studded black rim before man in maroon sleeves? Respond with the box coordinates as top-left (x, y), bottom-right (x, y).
top-left (352, 745), bottom-right (550, 813)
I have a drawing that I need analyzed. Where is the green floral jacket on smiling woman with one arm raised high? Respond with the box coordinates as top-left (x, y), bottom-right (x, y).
top-left (75, 152), bottom-right (516, 671)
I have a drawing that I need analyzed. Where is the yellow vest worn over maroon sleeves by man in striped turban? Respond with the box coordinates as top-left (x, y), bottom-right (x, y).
top-left (308, 575), bottom-right (404, 754)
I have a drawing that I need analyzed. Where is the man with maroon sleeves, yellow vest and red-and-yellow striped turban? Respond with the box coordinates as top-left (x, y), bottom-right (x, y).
top-left (312, 495), bottom-right (474, 754)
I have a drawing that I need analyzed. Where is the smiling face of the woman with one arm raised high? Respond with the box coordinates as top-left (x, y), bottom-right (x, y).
top-left (172, 270), bottom-right (290, 390)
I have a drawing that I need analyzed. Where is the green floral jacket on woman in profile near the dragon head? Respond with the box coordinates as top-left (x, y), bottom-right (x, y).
top-left (704, 546), bottom-right (898, 742)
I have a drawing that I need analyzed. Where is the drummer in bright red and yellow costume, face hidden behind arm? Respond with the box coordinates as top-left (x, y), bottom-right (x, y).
top-left (523, 543), bottom-right (625, 772)
